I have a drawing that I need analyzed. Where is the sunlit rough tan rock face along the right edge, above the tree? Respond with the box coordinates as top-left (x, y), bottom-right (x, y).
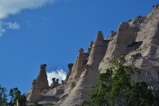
top-left (125, 5), bottom-right (159, 84)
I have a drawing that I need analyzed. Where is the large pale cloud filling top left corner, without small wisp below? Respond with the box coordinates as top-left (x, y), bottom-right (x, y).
top-left (0, 0), bottom-right (56, 19)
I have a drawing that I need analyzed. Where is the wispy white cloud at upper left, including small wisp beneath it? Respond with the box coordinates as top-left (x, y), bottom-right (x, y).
top-left (0, 0), bottom-right (56, 36)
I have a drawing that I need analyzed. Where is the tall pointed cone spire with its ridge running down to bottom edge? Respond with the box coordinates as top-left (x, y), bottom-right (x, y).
top-left (61, 31), bottom-right (109, 106)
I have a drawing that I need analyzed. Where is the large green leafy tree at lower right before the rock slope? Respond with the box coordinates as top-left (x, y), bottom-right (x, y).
top-left (82, 57), bottom-right (156, 106)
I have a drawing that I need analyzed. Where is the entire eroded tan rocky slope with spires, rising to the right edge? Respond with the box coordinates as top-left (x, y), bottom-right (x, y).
top-left (27, 5), bottom-right (159, 106)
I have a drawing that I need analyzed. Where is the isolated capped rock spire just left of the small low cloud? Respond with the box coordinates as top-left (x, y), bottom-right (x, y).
top-left (36, 64), bottom-right (49, 92)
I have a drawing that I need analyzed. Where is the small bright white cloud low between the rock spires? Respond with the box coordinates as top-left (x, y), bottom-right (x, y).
top-left (47, 69), bottom-right (66, 85)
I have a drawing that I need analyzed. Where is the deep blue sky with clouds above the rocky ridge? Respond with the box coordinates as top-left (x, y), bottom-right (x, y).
top-left (0, 0), bottom-right (159, 93)
